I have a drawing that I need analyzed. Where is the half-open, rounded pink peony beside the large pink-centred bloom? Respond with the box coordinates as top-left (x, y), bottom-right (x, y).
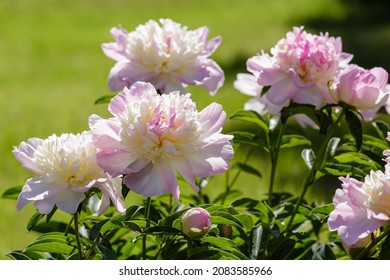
top-left (330, 65), bottom-right (389, 120)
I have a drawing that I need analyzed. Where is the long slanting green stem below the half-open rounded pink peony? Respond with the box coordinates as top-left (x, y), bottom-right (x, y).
top-left (286, 109), bottom-right (346, 236)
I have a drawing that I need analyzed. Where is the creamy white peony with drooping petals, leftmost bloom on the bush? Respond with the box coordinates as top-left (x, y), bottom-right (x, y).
top-left (13, 132), bottom-right (126, 214)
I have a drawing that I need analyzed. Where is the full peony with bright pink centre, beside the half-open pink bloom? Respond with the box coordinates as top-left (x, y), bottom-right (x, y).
top-left (247, 27), bottom-right (352, 109)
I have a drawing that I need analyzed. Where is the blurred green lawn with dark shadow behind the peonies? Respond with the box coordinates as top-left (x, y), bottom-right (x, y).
top-left (0, 0), bottom-right (390, 259)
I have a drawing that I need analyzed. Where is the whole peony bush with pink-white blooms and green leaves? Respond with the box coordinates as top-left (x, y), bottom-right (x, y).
top-left (3, 19), bottom-right (390, 260)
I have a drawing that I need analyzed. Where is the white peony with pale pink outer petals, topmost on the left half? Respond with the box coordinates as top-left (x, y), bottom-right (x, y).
top-left (102, 19), bottom-right (224, 95)
